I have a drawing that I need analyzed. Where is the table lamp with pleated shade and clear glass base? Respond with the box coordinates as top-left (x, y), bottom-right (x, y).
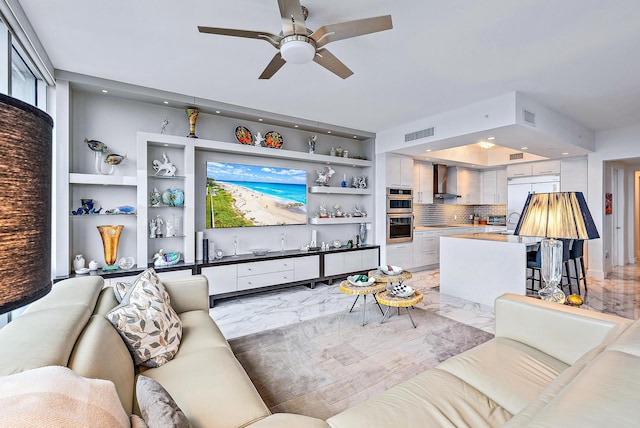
top-left (514, 192), bottom-right (600, 303)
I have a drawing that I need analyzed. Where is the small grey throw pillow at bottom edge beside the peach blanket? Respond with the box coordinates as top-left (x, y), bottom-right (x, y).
top-left (136, 376), bottom-right (189, 428)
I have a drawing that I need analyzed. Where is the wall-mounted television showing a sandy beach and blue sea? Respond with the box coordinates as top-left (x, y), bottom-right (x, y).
top-left (206, 162), bottom-right (307, 229)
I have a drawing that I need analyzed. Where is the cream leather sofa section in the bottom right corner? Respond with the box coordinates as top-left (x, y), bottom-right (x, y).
top-left (327, 294), bottom-right (640, 428)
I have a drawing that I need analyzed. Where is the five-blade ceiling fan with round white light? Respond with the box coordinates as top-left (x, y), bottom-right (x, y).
top-left (198, 0), bottom-right (393, 79)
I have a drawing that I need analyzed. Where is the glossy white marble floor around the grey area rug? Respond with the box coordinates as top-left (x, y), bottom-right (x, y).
top-left (210, 265), bottom-right (640, 340)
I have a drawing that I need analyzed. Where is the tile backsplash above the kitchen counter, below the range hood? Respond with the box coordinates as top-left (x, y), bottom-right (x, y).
top-left (413, 204), bottom-right (507, 226)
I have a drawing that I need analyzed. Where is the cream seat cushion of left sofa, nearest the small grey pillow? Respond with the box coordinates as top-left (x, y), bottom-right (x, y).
top-left (134, 347), bottom-right (270, 428)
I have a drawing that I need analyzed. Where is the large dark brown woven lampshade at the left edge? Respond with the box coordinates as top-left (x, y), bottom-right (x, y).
top-left (0, 94), bottom-right (53, 314)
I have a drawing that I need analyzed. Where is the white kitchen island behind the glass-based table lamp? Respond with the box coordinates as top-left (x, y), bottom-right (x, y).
top-left (440, 233), bottom-right (541, 308)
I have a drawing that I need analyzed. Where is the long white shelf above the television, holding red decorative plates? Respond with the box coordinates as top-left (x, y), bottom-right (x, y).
top-left (139, 133), bottom-right (373, 168)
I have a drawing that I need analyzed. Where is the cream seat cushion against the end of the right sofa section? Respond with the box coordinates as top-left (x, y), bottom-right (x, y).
top-left (437, 337), bottom-right (568, 414)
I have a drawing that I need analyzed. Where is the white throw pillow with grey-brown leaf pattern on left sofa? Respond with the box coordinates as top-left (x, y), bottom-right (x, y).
top-left (107, 269), bottom-right (182, 367)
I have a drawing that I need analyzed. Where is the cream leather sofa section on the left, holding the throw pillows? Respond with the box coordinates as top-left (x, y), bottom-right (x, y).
top-left (0, 275), bottom-right (327, 428)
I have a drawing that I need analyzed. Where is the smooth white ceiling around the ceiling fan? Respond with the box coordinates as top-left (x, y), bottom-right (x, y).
top-left (19, 0), bottom-right (640, 152)
